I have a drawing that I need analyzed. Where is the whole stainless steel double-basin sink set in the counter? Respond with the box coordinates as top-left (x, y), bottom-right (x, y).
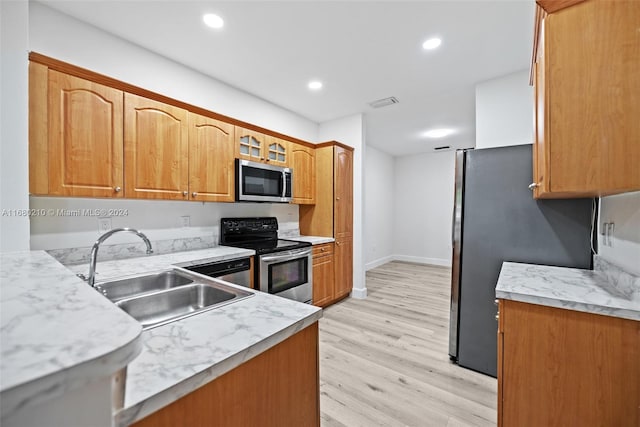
top-left (96, 269), bottom-right (253, 329)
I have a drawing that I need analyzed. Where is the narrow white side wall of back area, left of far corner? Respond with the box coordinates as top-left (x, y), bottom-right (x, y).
top-left (363, 146), bottom-right (395, 270)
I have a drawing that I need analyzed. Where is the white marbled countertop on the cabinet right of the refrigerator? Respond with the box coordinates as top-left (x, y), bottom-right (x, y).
top-left (496, 262), bottom-right (640, 321)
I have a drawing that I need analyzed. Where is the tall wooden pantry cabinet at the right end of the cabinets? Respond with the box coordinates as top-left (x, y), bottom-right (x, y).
top-left (300, 142), bottom-right (353, 302)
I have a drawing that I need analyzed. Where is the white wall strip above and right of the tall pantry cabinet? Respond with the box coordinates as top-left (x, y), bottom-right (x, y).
top-left (318, 114), bottom-right (368, 298)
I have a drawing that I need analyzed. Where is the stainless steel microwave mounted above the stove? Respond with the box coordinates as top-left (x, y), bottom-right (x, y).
top-left (236, 159), bottom-right (293, 203)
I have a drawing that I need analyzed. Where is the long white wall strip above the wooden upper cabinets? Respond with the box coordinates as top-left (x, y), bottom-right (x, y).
top-left (29, 3), bottom-right (318, 141)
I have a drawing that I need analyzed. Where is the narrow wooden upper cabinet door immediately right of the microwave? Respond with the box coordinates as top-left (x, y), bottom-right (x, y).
top-left (289, 143), bottom-right (316, 205)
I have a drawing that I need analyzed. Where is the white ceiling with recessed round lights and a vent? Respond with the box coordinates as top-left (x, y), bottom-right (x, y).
top-left (41, 0), bottom-right (535, 155)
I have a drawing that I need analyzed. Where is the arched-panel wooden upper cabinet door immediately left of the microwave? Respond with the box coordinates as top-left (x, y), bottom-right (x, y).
top-left (189, 113), bottom-right (235, 202)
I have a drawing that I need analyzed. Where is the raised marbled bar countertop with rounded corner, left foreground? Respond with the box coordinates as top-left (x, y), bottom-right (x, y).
top-left (0, 251), bottom-right (142, 416)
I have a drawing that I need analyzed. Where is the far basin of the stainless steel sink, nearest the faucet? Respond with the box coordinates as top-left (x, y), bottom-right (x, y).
top-left (97, 270), bottom-right (194, 302)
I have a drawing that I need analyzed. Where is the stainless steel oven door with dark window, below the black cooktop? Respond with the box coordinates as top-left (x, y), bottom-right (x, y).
top-left (259, 247), bottom-right (313, 303)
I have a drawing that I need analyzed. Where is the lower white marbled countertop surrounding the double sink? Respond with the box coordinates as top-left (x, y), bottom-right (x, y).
top-left (69, 246), bottom-right (322, 426)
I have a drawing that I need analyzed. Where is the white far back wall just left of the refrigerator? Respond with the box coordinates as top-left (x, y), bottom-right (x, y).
top-left (393, 151), bottom-right (455, 266)
